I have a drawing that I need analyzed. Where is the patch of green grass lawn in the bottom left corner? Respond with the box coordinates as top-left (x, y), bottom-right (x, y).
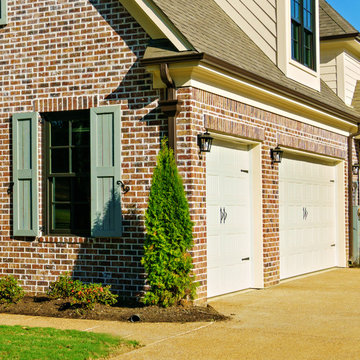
top-left (0, 326), bottom-right (138, 360)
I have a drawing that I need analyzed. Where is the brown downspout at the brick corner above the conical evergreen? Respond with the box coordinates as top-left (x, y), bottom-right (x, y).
top-left (159, 64), bottom-right (181, 160)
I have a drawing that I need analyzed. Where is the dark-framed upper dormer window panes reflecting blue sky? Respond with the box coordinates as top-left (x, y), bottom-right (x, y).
top-left (291, 0), bottom-right (316, 70)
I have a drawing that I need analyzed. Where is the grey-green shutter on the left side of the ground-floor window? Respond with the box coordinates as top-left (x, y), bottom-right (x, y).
top-left (12, 112), bottom-right (39, 236)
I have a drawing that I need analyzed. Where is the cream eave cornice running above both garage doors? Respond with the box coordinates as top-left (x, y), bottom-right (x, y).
top-left (146, 61), bottom-right (358, 136)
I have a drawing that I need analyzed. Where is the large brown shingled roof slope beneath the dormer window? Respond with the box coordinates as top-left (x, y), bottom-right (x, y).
top-left (146, 0), bottom-right (359, 121)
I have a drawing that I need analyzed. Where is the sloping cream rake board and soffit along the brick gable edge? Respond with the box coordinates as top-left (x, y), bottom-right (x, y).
top-left (119, 0), bottom-right (194, 51)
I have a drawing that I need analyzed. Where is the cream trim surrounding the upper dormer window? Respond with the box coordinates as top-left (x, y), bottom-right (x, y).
top-left (277, 0), bottom-right (320, 91)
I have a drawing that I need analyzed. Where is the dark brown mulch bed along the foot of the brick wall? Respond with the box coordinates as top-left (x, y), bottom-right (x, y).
top-left (0, 296), bottom-right (227, 322)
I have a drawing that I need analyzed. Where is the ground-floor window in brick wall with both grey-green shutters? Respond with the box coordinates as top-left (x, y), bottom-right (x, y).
top-left (13, 106), bottom-right (122, 237)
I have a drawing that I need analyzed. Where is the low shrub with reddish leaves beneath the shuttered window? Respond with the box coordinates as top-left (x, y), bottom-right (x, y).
top-left (48, 273), bottom-right (118, 309)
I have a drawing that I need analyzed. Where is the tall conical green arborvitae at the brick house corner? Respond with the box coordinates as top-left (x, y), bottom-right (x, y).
top-left (142, 140), bottom-right (196, 307)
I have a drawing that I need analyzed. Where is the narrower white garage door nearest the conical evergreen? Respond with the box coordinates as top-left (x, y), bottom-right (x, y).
top-left (206, 142), bottom-right (251, 297)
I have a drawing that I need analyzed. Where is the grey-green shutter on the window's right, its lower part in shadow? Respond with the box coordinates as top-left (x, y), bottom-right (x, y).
top-left (90, 106), bottom-right (122, 237)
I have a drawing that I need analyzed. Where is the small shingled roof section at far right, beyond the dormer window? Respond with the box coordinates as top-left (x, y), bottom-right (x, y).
top-left (319, 0), bottom-right (359, 38)
